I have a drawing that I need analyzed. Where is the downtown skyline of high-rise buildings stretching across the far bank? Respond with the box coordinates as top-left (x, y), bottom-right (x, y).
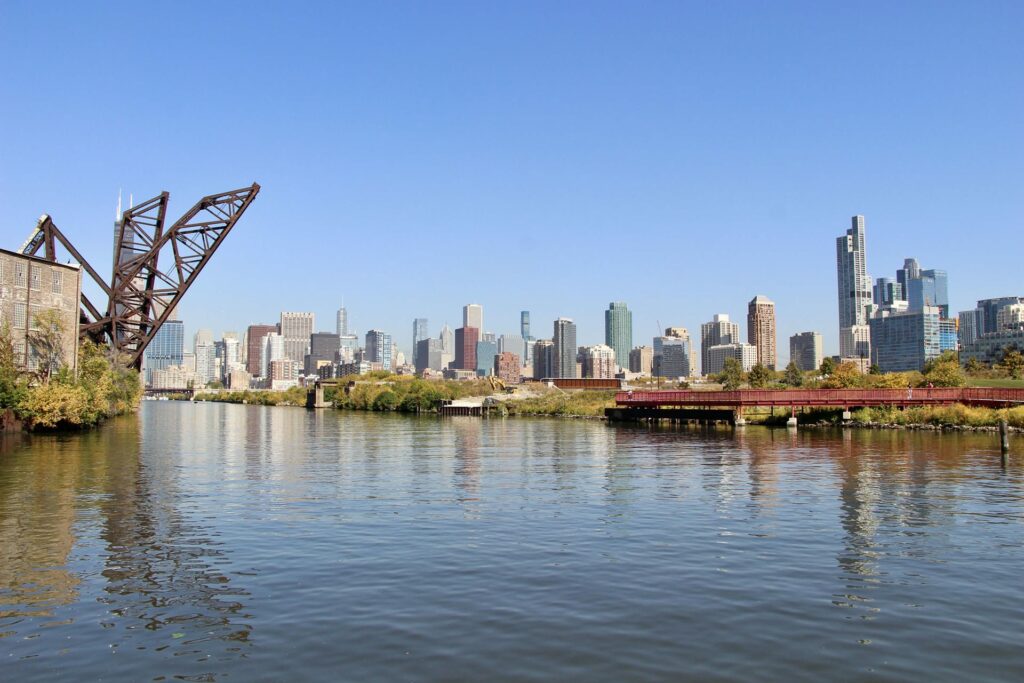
top-left (138, 216), bottom-right (1024, 389)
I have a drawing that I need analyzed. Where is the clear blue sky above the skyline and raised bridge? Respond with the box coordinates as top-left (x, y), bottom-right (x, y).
top-left (0, 0), bottom-right (1024, 356)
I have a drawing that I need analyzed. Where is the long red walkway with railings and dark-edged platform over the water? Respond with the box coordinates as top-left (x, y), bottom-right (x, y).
top-left (606, 387), bottom-right (1024, 424)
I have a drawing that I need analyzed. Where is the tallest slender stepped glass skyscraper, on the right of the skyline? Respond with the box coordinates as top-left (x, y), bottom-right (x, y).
top-left (836, 216), bottom-right (871, 358)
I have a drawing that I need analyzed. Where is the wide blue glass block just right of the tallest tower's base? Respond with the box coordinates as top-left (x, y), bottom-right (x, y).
top-left (868, 309), bottom-right (937, 373)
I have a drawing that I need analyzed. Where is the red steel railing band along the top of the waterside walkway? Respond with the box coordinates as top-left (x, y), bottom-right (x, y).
top-left (615, 387), bottom-right (1024, 408)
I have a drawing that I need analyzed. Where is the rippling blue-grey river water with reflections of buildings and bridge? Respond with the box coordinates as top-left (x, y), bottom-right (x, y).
top-left (0, 401), bottom-right (1024, 683)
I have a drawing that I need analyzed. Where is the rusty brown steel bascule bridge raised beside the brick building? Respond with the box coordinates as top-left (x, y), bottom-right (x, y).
top-left (20, 182), bottom-right (260, 369)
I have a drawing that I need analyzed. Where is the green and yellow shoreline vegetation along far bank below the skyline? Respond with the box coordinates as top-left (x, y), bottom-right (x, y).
top-left (182, 364), bottom-right (1024, 431)
